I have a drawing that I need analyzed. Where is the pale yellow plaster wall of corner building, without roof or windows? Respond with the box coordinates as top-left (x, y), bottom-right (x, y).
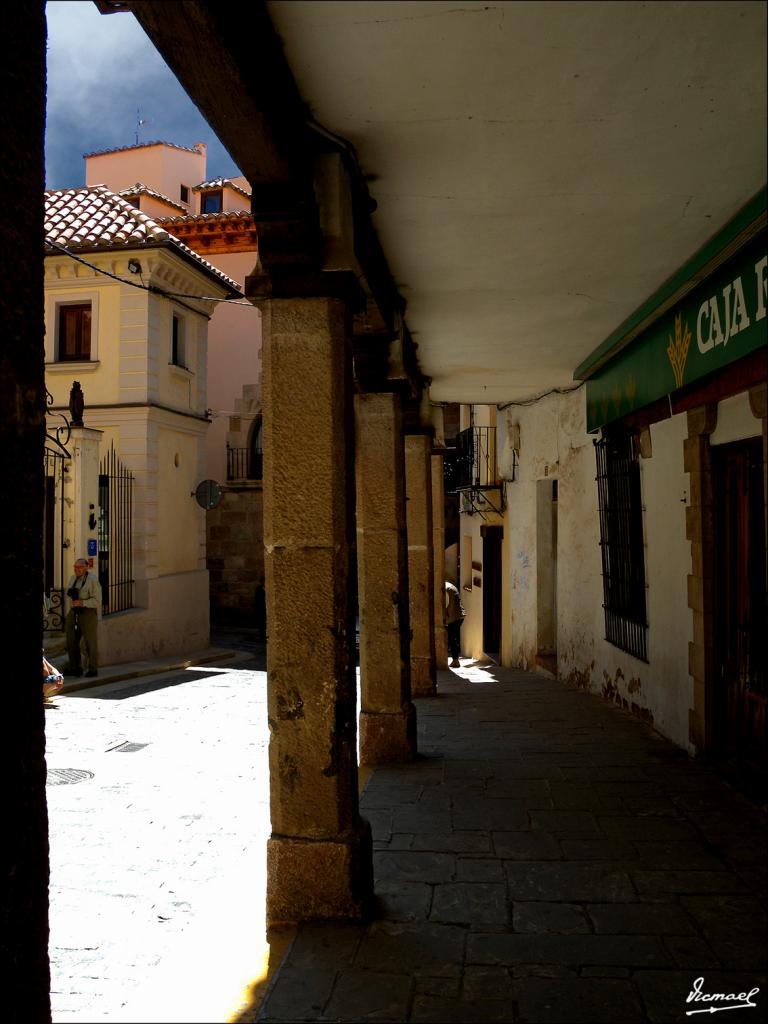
top-left (46, 251), bottom-right (217, 665)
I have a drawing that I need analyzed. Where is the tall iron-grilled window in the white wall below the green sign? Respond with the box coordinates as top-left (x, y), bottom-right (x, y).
top-left (595, 431), bottom-right (648, 662)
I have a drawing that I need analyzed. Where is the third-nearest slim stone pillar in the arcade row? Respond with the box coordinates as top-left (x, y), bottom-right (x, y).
top-left (406, 434), bottom-right (436, 697)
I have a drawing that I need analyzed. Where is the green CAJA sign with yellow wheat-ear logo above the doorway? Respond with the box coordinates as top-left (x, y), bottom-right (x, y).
top-left (587, 230), bottom-right (768, 431)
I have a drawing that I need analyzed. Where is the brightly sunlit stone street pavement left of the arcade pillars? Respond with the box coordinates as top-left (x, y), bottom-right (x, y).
top-left (46, 647), bottom-right (269, 1022)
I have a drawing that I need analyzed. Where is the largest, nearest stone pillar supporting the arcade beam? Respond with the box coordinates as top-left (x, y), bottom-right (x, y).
top-left (259, 292), bottom-right (373, 924)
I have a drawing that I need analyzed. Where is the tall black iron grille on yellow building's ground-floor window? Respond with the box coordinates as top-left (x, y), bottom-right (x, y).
top-left (98, 445), bottom-right (133, 615)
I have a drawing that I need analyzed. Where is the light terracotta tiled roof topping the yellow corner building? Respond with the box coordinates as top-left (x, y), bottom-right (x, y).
top-left (45, 185), bottom-right (242, 294)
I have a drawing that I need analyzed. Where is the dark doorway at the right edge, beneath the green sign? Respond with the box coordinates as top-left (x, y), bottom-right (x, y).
top-left (712, 438), bottom-right (768, 776)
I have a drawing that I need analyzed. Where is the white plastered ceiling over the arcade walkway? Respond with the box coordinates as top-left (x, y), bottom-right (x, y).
top-left (268, 0), bottom-right (766, 402)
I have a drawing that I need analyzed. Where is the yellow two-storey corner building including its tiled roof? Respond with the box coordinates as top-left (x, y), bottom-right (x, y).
top-left (45, 186), bottom-right (238, 664)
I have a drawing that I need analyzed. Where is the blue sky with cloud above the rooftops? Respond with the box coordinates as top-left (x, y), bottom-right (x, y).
top-left (45, 0), bottom-right (239, 188)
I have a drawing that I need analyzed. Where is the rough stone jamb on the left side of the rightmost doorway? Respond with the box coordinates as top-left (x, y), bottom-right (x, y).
top-left (684, 406), bottom-right (717, 754)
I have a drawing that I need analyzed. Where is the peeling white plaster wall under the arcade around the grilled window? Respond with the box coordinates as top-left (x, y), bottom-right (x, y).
top-left (499, 389), bottom-right (692, 748)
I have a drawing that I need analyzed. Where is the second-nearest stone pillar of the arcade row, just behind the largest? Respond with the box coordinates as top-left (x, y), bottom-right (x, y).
top-left (354, 394), bottom-right (416, 765)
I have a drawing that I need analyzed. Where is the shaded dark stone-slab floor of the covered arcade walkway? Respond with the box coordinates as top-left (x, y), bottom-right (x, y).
top-left (256, 663), bottom-right (768, 1024)
